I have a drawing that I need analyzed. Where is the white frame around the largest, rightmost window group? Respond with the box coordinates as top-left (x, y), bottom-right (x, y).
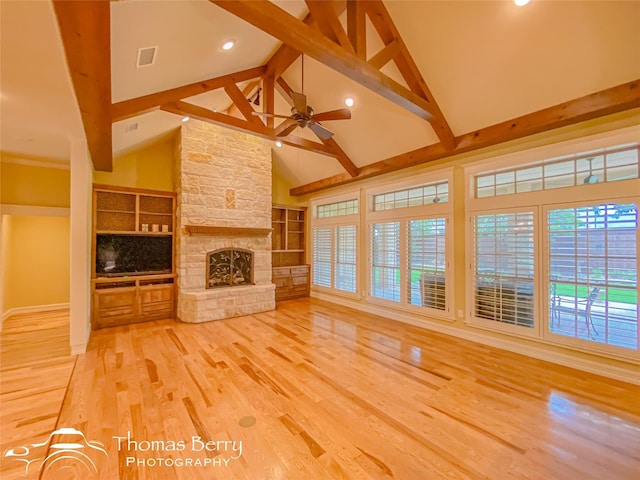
top-left (464, 125), bottom-right (640, 363)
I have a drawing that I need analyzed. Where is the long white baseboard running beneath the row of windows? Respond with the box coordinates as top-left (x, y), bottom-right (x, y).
top-left (311, 292), bottom-right (640, 385)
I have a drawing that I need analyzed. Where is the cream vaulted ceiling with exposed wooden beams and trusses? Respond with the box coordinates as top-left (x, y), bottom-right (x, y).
top-left (0, 0), bottom-right (640, 194)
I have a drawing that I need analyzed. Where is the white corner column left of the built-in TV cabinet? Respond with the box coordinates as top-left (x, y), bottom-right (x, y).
top-left (69, 139), bottom-right (93, 355)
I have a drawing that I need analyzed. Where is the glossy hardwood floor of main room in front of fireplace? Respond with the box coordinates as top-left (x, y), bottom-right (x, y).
top-left (2, 298), bottom-right (640, 480)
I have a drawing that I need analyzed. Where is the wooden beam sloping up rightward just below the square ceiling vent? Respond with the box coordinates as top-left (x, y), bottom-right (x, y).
top-left (112, 65), bottom-right (266, 123)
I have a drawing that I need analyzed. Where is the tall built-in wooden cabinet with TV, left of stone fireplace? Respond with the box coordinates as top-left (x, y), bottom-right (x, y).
top-left (91, 185), bottom-right (176, 328)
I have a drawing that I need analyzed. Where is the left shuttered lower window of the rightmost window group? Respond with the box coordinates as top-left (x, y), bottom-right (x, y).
top-left (473, 212), bottom-right (534, 328)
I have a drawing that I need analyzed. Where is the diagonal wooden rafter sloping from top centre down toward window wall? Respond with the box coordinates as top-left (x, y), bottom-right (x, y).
top-left (364, 0), bottom-right (456, 149)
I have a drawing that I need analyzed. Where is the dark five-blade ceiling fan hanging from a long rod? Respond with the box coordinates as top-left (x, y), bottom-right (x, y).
top-left (253, 57), bottom-right (351, 140)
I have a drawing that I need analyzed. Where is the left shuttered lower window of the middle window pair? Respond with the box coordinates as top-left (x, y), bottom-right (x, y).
top-left (370, 222), bottom-right (400, 302)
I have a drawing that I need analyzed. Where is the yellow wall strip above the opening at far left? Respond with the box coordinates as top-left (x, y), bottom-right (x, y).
top-left (0, 160), bottom-right (71, 207)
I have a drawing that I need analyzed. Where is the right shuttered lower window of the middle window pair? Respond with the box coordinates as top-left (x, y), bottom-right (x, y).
top-left (407, 218), bottom-right (446, 310)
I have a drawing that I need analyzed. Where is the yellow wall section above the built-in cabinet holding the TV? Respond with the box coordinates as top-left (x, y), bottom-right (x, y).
top-left (93, 138), bottom-right (176, 192)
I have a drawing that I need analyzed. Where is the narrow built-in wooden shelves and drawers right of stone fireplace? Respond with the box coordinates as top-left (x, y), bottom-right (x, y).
top-left (271, 205), bottom-right (310, 300)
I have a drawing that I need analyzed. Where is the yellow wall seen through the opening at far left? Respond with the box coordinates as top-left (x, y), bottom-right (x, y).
top-left (2, 215), bottom-right (69, 312)
